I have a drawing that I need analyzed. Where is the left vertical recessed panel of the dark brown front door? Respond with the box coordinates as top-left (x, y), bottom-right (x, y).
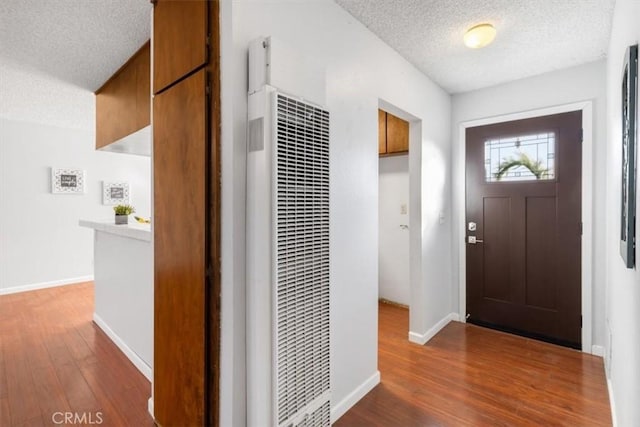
top-left (482, 197), bottom-right (513, 301)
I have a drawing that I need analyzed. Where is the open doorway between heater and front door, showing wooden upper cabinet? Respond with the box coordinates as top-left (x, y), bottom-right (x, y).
top-left (377, 100), bottom-right (424, 354)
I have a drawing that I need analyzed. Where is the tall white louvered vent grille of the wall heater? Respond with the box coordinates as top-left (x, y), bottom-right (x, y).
top-left (274, 94), bottom-right (330, 427)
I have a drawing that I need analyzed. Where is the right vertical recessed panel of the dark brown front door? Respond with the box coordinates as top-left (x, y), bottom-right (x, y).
top-left (525, 197), bottom-right (558, 309)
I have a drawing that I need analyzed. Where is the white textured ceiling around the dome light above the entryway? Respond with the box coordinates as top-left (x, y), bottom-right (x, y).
top-left (336, 0), bottom-right (615, 93)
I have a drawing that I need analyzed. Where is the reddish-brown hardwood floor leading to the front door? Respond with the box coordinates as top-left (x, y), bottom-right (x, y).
top-left (335, 304), bottom-right (611, 427)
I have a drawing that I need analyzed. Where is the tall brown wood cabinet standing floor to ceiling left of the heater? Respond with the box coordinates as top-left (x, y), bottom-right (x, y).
top-left (153, 0), bottom-right (220, 426)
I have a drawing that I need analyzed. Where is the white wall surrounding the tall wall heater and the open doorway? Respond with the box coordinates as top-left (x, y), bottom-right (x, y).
top-left (221, 0), bottom-right (451, 426)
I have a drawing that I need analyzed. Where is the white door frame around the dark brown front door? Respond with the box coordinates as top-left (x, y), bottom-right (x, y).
top-left (454, 101), bottom-right (593, 353)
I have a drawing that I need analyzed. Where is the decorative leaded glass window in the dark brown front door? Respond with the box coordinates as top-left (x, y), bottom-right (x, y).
top-left (484, 132), bottom-right (556, 182)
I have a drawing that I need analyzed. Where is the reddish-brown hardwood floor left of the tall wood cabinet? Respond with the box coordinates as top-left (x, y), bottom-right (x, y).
top-left (0, 283), bottom-right (154, 426)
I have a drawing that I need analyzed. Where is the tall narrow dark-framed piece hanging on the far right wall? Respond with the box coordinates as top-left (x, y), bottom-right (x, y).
top-left (620, 45), bottom-right (638, 268)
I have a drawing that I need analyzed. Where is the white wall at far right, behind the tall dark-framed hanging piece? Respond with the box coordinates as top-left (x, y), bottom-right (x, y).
top-left (604, 0), bottom-right (640, 427)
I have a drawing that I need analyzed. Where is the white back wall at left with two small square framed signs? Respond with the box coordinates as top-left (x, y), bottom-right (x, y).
top-left (0, 119), bottom-right (150, 293)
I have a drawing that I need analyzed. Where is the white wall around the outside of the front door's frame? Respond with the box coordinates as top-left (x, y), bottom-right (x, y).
top-left (451, 61), bottom-right (607, 346)
